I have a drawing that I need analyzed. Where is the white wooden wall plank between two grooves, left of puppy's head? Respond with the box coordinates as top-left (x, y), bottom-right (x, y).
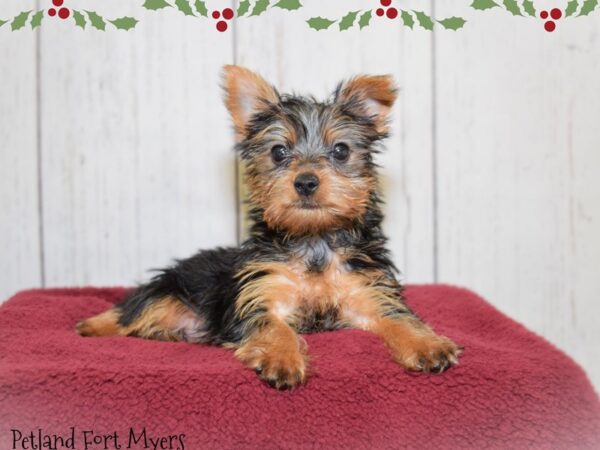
top-left (39, 0), bottom-right (237, 286)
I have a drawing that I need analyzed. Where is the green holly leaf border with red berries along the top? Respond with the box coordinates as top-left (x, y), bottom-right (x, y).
top-left (0, 0), bottom-right (600, 32)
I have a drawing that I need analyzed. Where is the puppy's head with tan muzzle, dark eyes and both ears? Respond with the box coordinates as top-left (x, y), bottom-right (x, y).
top-left (224, 66), bottom-right (396, 235)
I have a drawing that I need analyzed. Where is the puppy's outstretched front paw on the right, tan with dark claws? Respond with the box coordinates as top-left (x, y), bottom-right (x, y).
top-left (395, 334), bottom-right (462, 373)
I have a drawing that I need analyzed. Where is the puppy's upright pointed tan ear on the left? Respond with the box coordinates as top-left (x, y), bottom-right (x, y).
top-left (223, 66), bottom-right (279, 139)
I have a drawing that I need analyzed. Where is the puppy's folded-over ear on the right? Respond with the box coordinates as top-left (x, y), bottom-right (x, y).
top-left (334, 75), bottom-right (398, 133)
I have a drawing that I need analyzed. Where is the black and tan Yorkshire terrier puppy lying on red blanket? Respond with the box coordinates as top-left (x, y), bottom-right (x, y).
top-left (77, 66), bottom-right (460, 389)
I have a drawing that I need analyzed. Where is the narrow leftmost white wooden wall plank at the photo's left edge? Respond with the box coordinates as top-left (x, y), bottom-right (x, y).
top-left (0, 0), bottom-right (43, 299)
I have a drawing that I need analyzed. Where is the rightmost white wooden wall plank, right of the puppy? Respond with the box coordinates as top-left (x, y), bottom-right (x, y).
top-left (435, 0), bottom-right (600, 386)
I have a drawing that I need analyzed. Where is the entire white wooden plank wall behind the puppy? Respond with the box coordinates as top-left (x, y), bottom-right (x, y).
top-left (0, 0), bottom-right (600, 386)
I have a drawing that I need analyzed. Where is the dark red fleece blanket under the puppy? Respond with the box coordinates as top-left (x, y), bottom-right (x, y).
top-left (0, 285), bottom-right (600, 450)
